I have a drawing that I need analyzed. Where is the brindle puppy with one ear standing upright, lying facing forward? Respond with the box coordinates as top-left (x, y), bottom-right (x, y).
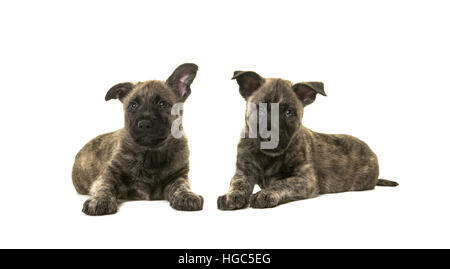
top-left (72, 64), bottom-right (203, 215)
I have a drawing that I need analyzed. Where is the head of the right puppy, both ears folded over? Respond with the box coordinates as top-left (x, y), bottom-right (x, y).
top-left (232, 71), bottom-right (326, 155)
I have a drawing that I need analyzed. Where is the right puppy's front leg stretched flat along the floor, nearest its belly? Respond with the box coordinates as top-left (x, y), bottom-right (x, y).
top-left (250, 176), bottom-right (319, 208)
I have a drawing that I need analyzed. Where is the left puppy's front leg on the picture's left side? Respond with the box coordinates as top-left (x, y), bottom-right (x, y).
top-left (82, 167), bottom-right (118, 216)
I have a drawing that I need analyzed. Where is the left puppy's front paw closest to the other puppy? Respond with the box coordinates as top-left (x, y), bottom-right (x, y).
top-left (164, 177), bottom-right (203, 211)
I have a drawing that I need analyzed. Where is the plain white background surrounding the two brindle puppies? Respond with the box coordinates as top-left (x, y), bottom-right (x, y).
top-left (0, 1), bottom-right (450, 248)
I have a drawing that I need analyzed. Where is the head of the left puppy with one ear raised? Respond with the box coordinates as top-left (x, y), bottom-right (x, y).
top-left (105, 63), bottom-right (198, 148)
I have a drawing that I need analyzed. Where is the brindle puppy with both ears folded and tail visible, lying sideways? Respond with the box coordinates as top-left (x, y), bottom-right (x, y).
top-left (217, 71), bottom-right (398, 210)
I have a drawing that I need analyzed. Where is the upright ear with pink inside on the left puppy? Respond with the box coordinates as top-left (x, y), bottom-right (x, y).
top-left (166, 63), bottom-right (198, 102)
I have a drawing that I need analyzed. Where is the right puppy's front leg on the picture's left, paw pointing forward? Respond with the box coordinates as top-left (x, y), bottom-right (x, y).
top-left (217, 171), bottom-right (255, 210)
